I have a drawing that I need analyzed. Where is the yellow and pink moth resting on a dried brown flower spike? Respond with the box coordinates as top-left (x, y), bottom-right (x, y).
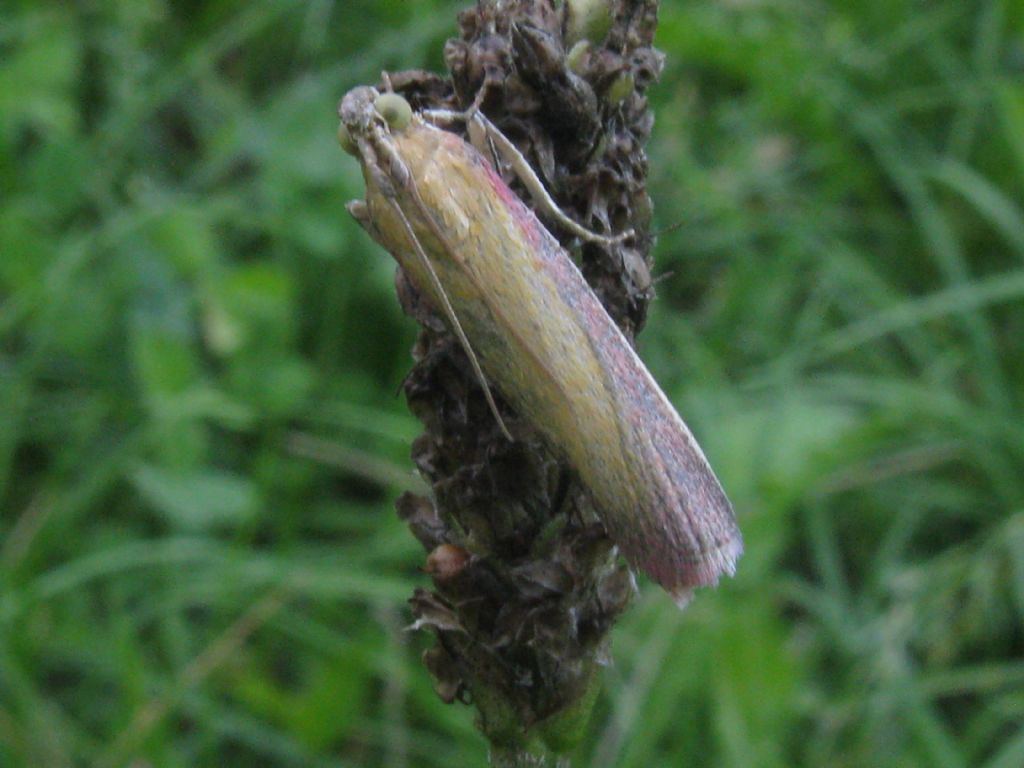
top-left (339, 87), bottom-right (742, 606)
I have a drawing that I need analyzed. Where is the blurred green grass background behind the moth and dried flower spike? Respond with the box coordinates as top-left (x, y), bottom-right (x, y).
top-left (0, 0), bottom-right (1024, 768)
